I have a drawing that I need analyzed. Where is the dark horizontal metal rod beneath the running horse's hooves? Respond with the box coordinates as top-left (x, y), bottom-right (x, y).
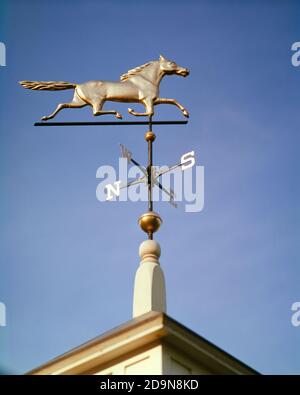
top-left (34, 121), bottom-right (188, 130)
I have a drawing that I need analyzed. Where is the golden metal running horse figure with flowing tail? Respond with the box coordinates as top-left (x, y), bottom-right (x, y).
top-left (20, 55), bottom-right (189, 121)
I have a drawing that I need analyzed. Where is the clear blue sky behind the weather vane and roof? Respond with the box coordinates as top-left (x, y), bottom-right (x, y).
top-left (0, 0), bottom-right (300, 374)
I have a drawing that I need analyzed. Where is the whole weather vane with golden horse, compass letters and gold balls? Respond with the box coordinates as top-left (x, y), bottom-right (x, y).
top-left (20, 55), bottom-right (194, 239)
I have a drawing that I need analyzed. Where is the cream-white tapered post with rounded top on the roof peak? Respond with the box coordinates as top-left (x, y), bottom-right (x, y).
top-left (133, 240), bottom-right (166, 318)
